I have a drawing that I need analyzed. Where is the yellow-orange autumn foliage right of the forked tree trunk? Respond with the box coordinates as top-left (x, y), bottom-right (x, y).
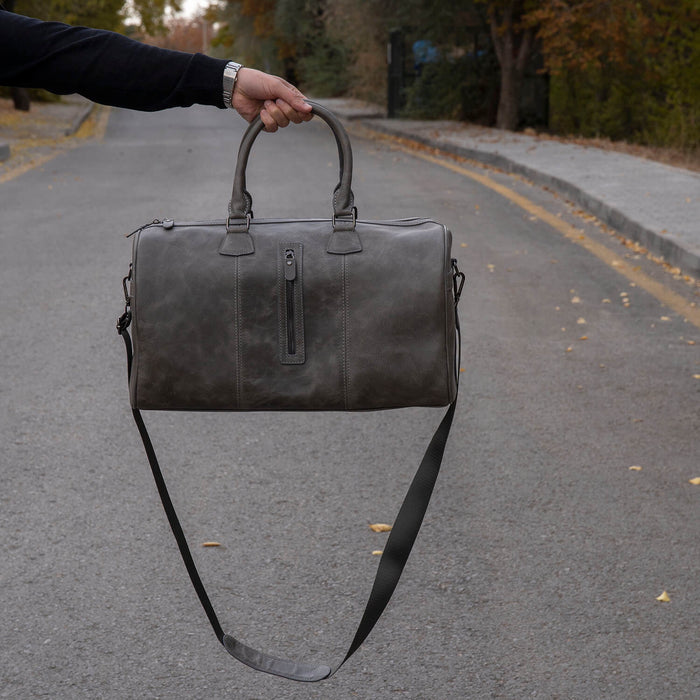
top-left (529, 0), bottom-right (700, 149)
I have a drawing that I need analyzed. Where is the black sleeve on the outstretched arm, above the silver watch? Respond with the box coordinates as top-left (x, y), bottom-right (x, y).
top-left (0, 9), bottom-right (227, 112)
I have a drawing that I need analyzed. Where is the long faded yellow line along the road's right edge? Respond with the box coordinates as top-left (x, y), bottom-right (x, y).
top-left (370, 129), bottom-right (700, 328)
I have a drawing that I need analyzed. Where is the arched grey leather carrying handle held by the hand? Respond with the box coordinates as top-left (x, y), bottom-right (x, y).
top-left (228, 100), bottom-right (354, 223)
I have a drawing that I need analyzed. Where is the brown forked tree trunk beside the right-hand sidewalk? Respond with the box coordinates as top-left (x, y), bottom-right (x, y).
top-left (489, 0), bottom-right (534, 131)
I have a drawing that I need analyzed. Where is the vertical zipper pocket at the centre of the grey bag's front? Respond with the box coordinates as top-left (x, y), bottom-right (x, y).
top-left (278, 243), bottom-right (306, 365)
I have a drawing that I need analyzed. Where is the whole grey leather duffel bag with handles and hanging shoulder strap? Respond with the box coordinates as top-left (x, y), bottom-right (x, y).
top-left (117, 104), bottom-right (464, 681)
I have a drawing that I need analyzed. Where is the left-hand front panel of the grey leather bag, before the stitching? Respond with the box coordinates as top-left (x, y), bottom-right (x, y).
top-left (132, 226), bottom-right (239, 410)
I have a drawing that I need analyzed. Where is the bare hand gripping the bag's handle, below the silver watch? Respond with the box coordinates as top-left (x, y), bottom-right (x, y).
top-left (231, 68), bottom-right (313, 132)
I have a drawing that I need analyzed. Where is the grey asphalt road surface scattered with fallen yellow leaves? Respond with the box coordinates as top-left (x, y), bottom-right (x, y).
top-left (0, 109), bottom-right (700, 700)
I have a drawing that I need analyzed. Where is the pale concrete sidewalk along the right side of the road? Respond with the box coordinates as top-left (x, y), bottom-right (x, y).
top-left (320, 98), bottom-right (700, 278)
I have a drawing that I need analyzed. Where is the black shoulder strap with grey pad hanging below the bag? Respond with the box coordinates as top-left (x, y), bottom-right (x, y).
top-left (117, 276), bottom-right (461, 681)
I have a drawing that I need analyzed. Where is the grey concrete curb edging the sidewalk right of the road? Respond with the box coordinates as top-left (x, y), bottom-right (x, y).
top-left (364, 119), bottom-right (700, 277)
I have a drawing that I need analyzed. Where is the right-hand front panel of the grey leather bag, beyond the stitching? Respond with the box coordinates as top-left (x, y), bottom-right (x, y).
top-left (344, 222), bottom-right (454, 410)
